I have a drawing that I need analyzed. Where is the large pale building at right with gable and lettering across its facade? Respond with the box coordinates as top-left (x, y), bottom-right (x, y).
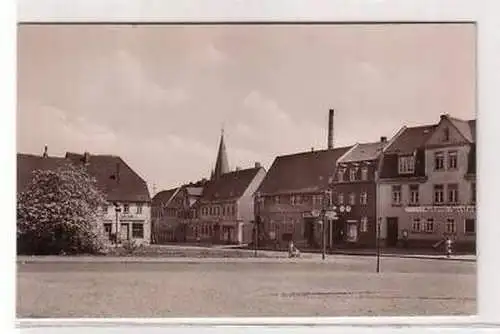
top-left (378, 115), bottom-right (476, 248)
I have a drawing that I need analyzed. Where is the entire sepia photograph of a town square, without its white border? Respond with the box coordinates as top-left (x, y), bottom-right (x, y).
top-left (16, 23), bottom-right (480, 319)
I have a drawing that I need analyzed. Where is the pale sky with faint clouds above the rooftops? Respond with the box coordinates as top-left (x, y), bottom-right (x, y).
top-left (17, 24), bottom-right (476, 192)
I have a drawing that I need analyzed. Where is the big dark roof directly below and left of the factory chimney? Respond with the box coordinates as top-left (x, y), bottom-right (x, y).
top-left (259, 146), bottom-right (352, 195)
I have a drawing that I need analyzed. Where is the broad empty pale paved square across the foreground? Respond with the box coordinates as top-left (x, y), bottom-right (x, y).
top-left (17, 256), bottom-right (476, 317)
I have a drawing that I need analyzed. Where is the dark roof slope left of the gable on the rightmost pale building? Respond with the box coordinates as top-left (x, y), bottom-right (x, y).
top-left (385, 124), bottom-right (437, 154)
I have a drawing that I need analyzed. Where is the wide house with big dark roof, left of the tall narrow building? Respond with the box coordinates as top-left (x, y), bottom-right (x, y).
top-left (256, 147), bottom-right (351, 248)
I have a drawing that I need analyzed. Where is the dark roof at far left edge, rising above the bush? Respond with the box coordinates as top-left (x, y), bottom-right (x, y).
top-left (17, 153), bottom-right (69, 192)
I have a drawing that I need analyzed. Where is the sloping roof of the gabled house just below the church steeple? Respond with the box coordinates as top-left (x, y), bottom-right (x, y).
top-left (200, 167), bottom-right (261, 201)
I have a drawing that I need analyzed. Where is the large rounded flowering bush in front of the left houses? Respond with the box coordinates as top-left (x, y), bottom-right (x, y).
top-left (17, 164), bottom-right (106, 255)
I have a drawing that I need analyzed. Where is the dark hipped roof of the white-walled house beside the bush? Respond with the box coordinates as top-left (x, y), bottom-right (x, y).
top-left (66, 153), bottom-right (151, 202)
